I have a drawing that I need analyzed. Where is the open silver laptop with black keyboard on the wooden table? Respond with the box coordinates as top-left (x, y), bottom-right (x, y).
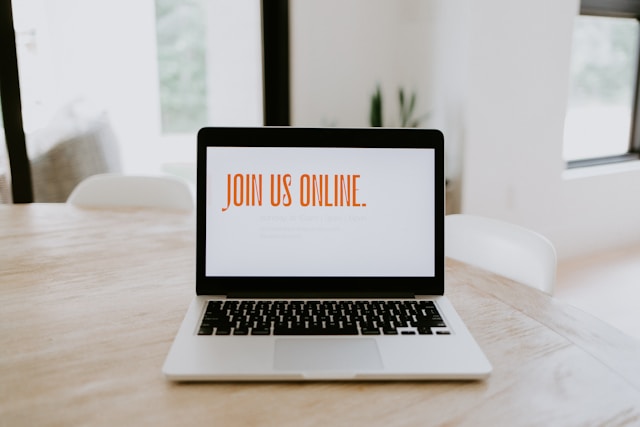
top-left (162, 127), bottom-right (492, 381)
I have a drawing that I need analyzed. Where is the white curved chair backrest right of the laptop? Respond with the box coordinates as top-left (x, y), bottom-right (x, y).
top-left (445, 214), bottom-right (557, 294)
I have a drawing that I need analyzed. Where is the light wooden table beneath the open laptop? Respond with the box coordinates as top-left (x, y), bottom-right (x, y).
top-left (0, 204), bottom-right (640, 427)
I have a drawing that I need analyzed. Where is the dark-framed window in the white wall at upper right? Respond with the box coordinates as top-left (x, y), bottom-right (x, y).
top-left (563, 0), bottom-right (640, 168)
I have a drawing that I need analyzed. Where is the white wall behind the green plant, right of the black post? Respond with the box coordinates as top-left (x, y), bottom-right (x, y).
top-left (290, 0), bottom-right (435, 130)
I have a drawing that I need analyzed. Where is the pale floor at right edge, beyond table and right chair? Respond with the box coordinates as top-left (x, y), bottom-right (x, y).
top-left (555, 245), bottom-right (640, 339)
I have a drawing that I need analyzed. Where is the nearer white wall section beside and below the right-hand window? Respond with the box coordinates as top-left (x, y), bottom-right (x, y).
top-left (462, 0), bottom-right (640, 258)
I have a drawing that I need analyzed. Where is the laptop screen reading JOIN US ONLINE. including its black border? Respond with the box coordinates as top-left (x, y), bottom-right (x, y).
top-left (197, 127), bottom-right (444, 298)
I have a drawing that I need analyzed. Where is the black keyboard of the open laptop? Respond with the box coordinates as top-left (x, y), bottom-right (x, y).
top-left (198, 300), bottom-right (450, 335)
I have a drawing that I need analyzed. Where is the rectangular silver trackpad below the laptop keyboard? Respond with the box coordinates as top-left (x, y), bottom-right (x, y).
top-left (275, 337), bottom-right (382, 371)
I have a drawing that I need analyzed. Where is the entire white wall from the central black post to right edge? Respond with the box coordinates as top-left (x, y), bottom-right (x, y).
top-left (292, 0), bottom-right (640, 258)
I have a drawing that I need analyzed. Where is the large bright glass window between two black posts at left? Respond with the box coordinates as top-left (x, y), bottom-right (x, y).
top-left (12, 0), bottom-right (263, 179)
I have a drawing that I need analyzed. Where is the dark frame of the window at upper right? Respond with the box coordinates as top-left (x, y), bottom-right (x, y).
top-left (567, 0), bottom-right (640, 169)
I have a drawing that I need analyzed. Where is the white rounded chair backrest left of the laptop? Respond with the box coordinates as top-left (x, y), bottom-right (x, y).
top-left (67, 173), bottom-right (195, 211)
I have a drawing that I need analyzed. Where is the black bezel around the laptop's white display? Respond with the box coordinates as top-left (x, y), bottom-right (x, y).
top-left (196, 126), bottom-right (445, 297)
